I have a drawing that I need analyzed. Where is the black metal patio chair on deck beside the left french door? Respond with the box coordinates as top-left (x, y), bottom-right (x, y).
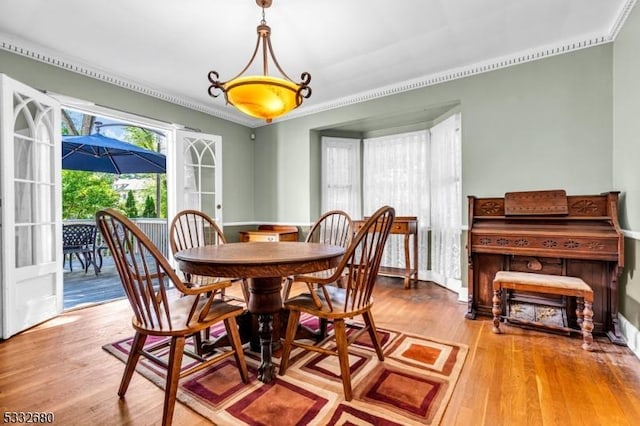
top-left (62, 223), bottom-right (100, 275)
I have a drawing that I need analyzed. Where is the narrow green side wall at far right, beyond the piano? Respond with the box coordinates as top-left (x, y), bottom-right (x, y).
top-left (612, 7), bottom-right (640, 332)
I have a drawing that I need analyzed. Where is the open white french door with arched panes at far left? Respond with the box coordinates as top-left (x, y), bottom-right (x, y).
top-left (0, 74), bottom-right (63, 339)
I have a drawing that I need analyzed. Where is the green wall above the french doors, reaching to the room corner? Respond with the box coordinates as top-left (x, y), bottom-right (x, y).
top-left (0, 50), bottom-right (254, 222)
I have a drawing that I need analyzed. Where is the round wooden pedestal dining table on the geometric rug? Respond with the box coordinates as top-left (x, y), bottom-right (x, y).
top-left (174, 241), bottom-right (345, 383)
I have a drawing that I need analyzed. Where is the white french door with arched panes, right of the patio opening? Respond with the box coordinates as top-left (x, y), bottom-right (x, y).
top-left (175, 130), bottom-right (222, 225)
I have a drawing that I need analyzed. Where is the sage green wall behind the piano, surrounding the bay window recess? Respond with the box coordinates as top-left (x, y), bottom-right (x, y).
top-left (255, 44), bottom-right (613, 223)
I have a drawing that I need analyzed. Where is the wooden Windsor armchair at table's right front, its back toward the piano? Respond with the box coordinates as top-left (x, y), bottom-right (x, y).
top-left (279, 206), bottom-right (395, 401)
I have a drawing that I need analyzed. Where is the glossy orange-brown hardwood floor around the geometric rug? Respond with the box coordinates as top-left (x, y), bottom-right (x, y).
top-left (0, 278), bottom-right (640, 425)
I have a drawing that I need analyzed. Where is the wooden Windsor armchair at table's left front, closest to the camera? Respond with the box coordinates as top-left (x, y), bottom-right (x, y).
top-left (96, 209), bottom-right (249, 425)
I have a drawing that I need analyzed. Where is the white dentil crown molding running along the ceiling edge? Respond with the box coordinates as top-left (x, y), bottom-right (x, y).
top-left (0, 0), bottom-right (637, 128)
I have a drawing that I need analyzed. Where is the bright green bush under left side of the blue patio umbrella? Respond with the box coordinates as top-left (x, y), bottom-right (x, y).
top-left (62, 170), bottom-right (118, 219)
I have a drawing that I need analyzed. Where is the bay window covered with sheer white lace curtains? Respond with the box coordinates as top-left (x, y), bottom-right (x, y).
top-left (322, 114), bottom-right (462, 290)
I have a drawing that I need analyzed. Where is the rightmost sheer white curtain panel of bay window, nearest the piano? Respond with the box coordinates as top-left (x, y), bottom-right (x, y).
top-left (430, 114), bottom-right (462, 289)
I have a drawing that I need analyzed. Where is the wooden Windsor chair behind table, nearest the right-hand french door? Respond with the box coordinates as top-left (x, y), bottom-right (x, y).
top-left (169, 210), bottom-right (249, 304)
